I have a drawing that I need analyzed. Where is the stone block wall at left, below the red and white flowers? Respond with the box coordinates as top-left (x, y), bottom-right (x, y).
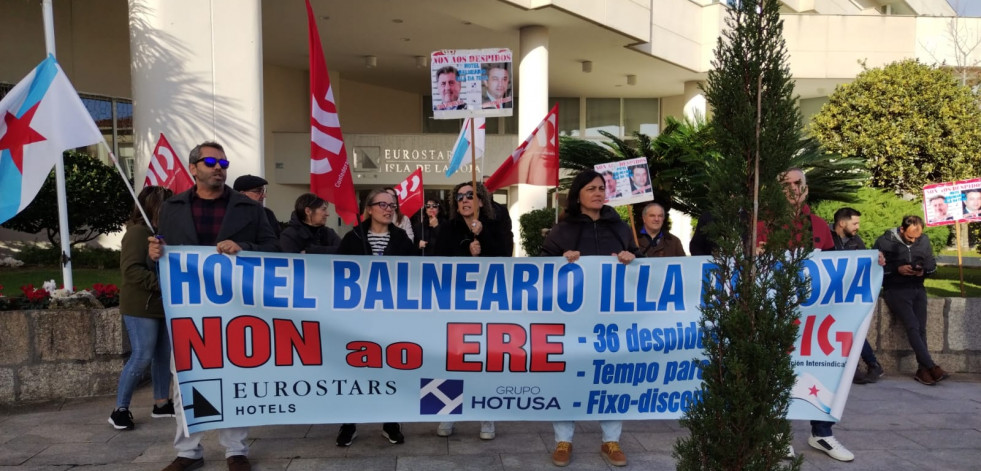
top-left (0, 308), bottom-right (130, 404)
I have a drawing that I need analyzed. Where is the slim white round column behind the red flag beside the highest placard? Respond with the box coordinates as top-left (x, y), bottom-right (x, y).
top-left (509, 26), bottom-right (550, 257)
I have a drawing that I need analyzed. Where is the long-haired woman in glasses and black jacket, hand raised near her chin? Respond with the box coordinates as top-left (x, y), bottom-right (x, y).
top-left (436, 182), bottom-right (511, 440)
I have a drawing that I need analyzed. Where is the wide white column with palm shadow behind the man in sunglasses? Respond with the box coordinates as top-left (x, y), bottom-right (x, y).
top-left (129, 0), bottom-right (263, 186)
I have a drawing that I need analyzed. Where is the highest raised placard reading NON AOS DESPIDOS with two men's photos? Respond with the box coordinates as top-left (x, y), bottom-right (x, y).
top-left (430, 48), bottom-right (514, 119)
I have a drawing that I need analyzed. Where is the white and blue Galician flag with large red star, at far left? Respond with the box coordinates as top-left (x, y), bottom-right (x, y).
top-left (0, 55), bottom-right (103, 223)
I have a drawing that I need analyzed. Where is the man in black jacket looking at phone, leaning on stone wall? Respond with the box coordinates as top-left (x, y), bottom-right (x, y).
top-left (874, 216), bottom-right (950, 386)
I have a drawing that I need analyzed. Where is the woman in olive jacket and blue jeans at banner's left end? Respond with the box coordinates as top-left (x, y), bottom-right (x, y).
top-left (109, 186), bottom-right (174, 430)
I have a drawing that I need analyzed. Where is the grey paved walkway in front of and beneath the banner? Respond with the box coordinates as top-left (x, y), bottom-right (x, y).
top-left (0, 373), bottom-right (981, 471)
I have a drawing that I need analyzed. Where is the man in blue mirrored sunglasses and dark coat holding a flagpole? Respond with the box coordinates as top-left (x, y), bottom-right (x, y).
top-left (149, 141), bottom-right (279, 471)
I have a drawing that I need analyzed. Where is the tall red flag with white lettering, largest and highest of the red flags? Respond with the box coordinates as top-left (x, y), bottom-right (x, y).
top-left (306, 0), bottom-right (358, 224)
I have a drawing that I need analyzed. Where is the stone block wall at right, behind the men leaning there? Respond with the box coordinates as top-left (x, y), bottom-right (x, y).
top-left (868, 298), bottom-right (981, 375)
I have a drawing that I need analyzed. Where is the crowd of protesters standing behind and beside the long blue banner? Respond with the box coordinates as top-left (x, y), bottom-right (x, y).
top-left (109, 142), bottom-right (949, 471)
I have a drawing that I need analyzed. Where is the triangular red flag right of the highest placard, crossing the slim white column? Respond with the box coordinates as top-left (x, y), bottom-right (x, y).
top-left (484, 104), bottom-right (559, 192)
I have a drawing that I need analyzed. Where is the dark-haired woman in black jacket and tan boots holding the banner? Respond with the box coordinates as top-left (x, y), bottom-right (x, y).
top-left (542, 170), bottom-right (640, 466)
